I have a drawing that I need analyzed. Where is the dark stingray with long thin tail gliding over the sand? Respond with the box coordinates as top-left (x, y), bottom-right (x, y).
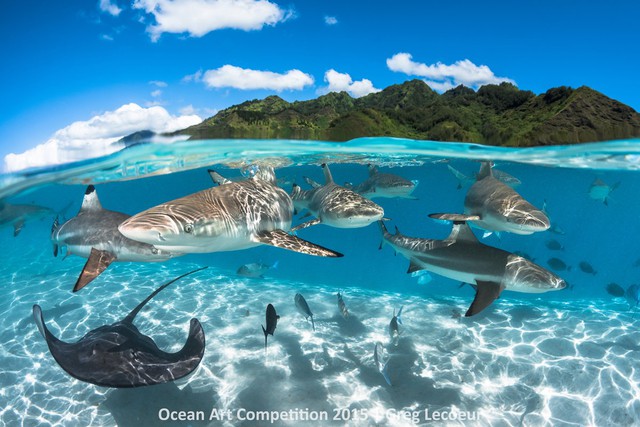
top-left (33, 267), bottom-right (207, 388)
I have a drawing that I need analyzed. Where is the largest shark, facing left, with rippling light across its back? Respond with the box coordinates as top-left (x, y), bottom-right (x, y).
top-left (118, 167), bottom-right (342, 257)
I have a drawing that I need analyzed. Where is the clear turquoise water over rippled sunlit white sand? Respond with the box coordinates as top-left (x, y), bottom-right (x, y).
top-left (0, 138), bottom-right (640, 426)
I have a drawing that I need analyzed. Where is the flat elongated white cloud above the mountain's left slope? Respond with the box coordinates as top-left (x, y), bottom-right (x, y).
top-left (198, 65), bottom-right (313, 92)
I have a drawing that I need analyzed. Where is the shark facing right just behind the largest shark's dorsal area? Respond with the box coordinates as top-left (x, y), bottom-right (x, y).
top-left (291, 163), bottom-right (384, 231)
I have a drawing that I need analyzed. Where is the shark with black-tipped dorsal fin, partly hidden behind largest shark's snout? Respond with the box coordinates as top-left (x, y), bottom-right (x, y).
top-left (51, 185), bottom-right (181, 292)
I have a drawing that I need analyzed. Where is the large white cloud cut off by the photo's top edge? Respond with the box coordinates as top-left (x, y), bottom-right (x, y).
top-left (133, 0), bottom-right (291, 41)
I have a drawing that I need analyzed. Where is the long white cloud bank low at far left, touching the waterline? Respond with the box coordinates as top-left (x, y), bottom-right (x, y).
top-left (4, 103), bottom-right (202, 172)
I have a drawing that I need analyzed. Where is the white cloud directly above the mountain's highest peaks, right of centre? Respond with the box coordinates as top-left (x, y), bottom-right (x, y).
top-left (387, 53), bottom-right (515, 91)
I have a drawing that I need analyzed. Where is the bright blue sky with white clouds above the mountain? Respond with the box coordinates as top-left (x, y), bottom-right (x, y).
top-left (0, 0), bottom-right (640, 172)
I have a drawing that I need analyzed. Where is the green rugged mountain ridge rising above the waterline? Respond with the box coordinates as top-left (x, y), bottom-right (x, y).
top-left (176, 80), bottom-right (640, 147)
